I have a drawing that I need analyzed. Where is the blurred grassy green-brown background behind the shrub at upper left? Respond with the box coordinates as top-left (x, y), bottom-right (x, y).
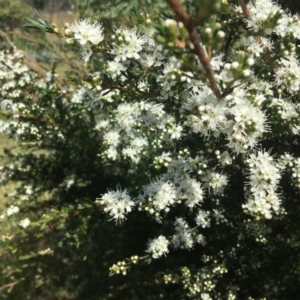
top-left (0, 0), bottom-right (166, 75)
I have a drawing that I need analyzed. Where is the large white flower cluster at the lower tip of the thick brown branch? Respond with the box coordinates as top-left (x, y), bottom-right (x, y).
top-left (183, 88), bottom-right (266, 152)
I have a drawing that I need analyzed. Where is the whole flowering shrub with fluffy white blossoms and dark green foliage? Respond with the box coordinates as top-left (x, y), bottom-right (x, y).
top-left (0, 0), bottom-right (300, 299)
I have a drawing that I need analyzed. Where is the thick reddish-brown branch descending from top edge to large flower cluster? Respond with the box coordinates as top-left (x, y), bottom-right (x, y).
top-left (166, 0), bottom-right (222, 99)
